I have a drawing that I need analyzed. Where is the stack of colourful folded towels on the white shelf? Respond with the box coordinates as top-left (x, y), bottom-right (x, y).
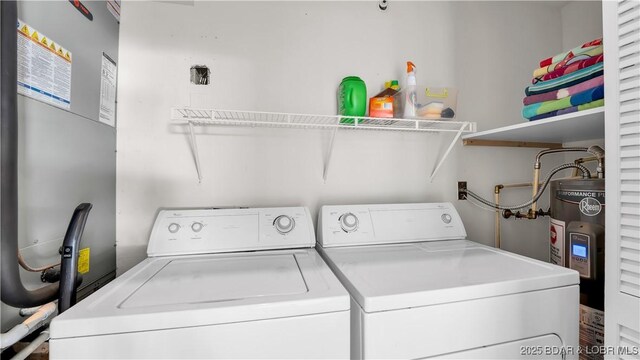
top-left (522, 39), bottom-right (604, 120)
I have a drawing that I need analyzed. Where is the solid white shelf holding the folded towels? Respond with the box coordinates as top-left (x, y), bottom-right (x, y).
top-left (462, 107), bottom-right (604, 148)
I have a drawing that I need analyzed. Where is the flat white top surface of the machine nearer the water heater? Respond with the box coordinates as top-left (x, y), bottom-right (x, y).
top-left (323, 240), bottom-right (580, 312)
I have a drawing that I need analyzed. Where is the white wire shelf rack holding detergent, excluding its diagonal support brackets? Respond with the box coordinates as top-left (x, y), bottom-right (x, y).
top-left (171, 108), bottom-right (476, 133)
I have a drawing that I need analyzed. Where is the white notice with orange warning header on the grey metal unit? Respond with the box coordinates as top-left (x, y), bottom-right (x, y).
top-left (18, 20), bottom-right (72, 109)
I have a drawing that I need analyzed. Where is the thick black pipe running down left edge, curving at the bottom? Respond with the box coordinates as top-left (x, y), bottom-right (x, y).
top-left (0, 1), bottom-right (58, 307)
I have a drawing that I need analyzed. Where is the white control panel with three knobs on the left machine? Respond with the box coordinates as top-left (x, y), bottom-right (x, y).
top-left (147, 207), bottom-right (315, 256)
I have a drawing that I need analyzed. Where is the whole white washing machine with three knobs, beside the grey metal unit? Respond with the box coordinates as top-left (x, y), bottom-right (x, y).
top-left (50, 207), bottom-right (350, 359)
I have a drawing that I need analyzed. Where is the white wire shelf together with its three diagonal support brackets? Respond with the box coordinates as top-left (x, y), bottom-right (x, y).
top-left (171, 107), bottom-right (476, 181)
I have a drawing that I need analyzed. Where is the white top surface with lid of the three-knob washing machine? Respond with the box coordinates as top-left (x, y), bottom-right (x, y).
top-left (51, 249), bottom-right (350, 338)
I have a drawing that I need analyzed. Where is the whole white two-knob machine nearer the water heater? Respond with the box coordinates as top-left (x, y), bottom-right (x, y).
top-left (318, 203), bottom-right (580, 359)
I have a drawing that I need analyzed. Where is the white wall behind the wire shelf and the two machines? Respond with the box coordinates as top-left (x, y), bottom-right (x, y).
top-left (117, 2), bottom-right (562, 273)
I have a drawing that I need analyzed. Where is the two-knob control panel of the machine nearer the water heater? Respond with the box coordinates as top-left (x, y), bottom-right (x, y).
top-left (318, 203), bottom-right (467, 247)
